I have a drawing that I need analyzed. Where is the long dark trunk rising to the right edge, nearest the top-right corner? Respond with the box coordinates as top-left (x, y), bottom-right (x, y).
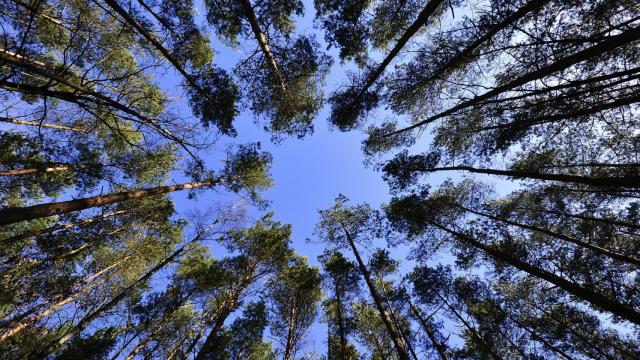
top-left (385, 29), bottom-right (640, 136)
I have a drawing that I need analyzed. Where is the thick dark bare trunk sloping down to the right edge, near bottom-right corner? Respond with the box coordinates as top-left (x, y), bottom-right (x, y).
top-left (432, 223), bottom-right (640, 325)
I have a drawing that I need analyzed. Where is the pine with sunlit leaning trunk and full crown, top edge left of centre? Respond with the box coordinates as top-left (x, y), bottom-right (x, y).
top-left (205, 0), bottom-right (331, 140)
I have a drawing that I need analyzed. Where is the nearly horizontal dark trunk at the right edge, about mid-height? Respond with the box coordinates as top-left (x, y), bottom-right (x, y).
top-left (423, 166), bottom-right (640, 188)
